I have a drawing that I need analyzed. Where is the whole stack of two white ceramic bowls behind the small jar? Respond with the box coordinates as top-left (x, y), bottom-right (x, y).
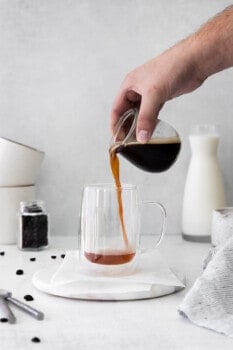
top-left (0, 138), bottom-right (44, 244)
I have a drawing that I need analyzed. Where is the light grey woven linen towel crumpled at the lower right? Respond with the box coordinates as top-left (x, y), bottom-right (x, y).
top-left (179, 237), bottom-right (233, 337)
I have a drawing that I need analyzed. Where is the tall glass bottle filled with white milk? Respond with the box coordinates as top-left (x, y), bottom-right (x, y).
top-left (182, 124), bottom-right (226, 242)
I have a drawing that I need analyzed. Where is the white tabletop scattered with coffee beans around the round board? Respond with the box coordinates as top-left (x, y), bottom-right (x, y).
top-left (0, 235), bottom-right (233, 350)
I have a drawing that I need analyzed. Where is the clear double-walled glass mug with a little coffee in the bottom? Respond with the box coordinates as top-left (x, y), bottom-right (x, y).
top-left (79, 184), bottom-right (166, 275)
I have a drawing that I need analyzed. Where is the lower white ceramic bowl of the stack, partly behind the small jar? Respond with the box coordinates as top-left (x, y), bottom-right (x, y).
top-left (0, 186), bottom-right (35, 244)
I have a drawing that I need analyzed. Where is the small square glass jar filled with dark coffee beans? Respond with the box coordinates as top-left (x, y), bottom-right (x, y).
top-left (18, 200), bottom-right (49, 250)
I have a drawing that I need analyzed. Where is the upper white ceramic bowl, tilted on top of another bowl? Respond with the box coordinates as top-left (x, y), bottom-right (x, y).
top-left (0, 137), bottom-right (44, 187)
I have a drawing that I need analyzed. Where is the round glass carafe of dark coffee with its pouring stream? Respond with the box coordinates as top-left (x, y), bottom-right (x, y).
top-left (109, 108), bottom-right (181, 250)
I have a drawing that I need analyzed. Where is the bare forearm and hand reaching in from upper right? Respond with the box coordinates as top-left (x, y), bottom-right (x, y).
top-left (111, 6), bottom-right (233, 142)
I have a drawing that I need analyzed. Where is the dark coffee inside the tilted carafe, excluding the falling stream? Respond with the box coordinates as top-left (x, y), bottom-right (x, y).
top-left (111, 137), bottom-right (181, 173)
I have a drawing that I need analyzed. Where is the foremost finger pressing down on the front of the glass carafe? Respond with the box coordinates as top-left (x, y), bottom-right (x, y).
top-left (136, 90), bottom-right (163, 143)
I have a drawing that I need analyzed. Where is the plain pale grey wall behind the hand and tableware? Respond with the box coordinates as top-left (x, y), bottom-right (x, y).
top-left (0, 0), bottom-right (233, 235)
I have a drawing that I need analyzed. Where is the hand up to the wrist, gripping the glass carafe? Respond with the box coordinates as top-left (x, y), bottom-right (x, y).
top-left (111, 40), bottom-right (205, 143)
